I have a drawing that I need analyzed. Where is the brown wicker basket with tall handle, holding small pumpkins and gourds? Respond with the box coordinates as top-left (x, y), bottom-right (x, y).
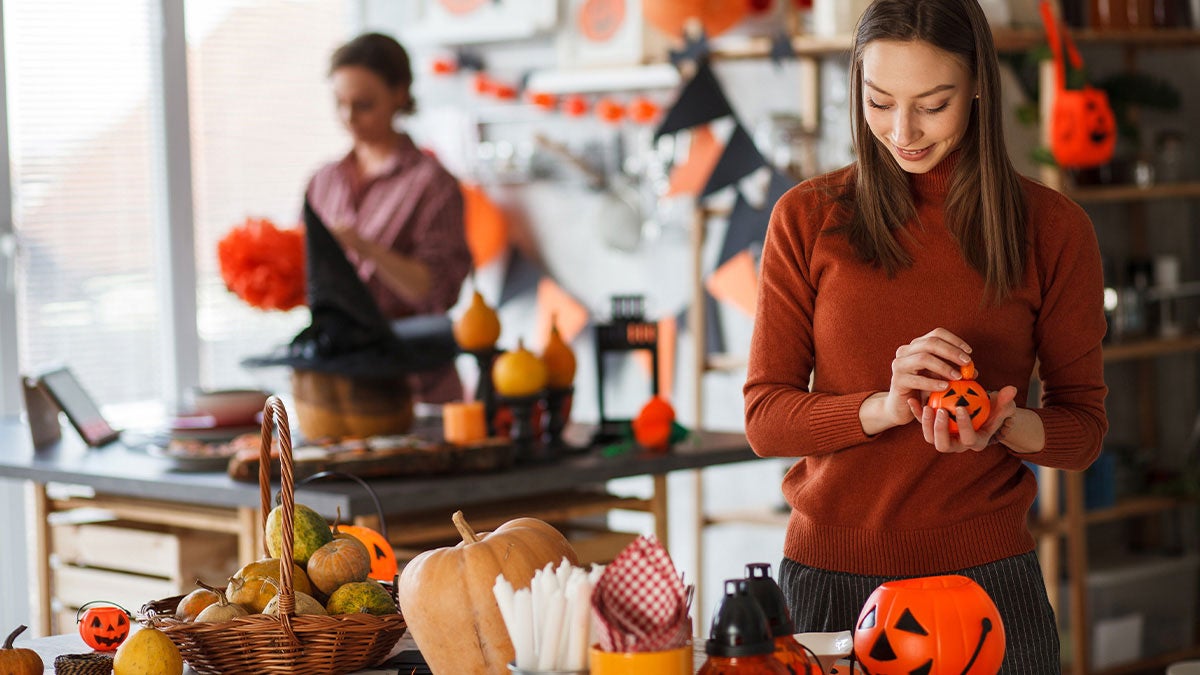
top-left (143, 396), bottom-right (404, 675)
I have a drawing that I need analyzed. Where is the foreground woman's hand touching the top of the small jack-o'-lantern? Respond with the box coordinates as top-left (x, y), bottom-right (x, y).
top-left (883, 328), bottom-right (971, 426)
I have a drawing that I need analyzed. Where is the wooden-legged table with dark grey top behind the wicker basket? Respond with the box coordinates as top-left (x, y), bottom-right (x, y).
top-left (0, 420), bottom-right (755, 635)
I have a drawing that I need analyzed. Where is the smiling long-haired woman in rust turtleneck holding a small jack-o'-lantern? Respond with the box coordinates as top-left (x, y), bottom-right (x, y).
top-left (744, 0), bottom-right (1108, 674)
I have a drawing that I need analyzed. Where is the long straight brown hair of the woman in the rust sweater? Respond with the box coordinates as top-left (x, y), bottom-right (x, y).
top-left (845, 0), bottom-right (1026, 299)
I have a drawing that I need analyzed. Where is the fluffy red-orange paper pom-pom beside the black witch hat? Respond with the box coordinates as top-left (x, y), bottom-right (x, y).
top-left (217, 217), bottom-right (306, 311)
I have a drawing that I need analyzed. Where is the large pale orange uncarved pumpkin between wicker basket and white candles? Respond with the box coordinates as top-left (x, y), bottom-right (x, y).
top-left (396, 510), bottom-right (578, 675)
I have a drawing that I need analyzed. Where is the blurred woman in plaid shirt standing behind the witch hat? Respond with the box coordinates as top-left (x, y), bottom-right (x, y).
top-left (306, 32), bottom-right (472, 402)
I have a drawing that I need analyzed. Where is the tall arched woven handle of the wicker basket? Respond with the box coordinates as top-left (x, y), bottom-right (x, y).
top-left (258, 396), bottom-right (299, 644)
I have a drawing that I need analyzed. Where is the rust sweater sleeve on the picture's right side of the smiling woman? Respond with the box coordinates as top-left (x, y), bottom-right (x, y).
top-left (1019, 195), bottom-right (1108, 471)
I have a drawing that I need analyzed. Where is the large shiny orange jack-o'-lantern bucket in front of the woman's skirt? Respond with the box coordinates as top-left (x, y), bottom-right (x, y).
top-left (854, 574), bottom-right (1004, 675)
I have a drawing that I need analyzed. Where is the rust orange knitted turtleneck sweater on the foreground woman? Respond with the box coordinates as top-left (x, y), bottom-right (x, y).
top-left (744, 155), bottom-right (1108, 575)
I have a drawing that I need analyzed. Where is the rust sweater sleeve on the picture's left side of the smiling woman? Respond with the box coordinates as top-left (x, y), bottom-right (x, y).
top-left (743, 185), bottom-right (871, 456)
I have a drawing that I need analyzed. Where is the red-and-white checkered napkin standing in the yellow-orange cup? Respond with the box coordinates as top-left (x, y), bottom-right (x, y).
top-left (592, 537), bottom-right (692, 652)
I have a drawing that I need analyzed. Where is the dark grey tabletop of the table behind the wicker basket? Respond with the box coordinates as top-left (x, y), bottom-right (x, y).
top-left (0, 419), bottom-right (756, 518)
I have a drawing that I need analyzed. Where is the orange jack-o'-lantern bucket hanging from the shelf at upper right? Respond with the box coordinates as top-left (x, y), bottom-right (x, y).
top-left (1050, 88), bottom-right (1117, 168)
